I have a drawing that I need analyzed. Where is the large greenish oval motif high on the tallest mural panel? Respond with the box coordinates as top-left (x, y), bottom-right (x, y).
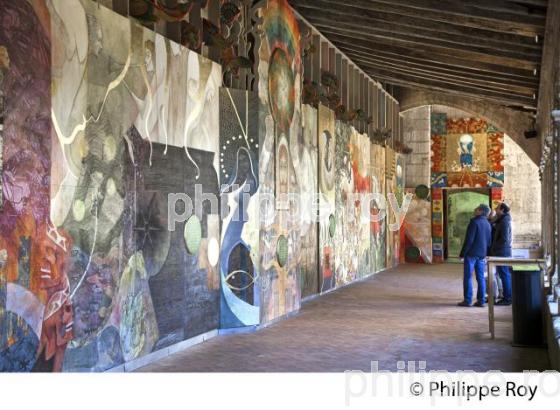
top-left (268, 48), bottom-right (296, 131)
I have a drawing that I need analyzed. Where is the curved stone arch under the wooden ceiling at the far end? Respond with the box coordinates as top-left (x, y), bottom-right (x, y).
top-left (397, 88), bottom-right (541, 165)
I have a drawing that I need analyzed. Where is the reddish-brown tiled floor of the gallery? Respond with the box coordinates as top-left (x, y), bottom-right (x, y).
top-left (140, 264), bottom-right (549, 372)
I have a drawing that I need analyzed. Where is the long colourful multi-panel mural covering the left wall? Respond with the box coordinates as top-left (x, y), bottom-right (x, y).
top-left (0, 0), bottom-right (402, 371)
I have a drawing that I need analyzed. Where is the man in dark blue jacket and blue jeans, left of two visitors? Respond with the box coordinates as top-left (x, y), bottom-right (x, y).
top-left (458, 204), bottom-right (492, 307)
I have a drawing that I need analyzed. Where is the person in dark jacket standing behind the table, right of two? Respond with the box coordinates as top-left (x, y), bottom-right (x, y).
top-left (490, 202), bottom-right (513, 306)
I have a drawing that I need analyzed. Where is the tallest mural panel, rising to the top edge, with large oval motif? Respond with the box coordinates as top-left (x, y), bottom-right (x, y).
top-left (255, 0), bottom-right (302, 323)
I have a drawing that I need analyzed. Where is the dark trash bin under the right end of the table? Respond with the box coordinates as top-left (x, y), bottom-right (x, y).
top-left (511, 267), bottom-right (544, 347)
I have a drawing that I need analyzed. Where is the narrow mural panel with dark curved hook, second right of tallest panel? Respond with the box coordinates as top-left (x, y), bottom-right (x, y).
top-left (317, 105), bottom-right (339, 292)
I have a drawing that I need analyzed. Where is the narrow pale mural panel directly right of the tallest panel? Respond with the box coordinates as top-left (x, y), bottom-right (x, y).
top-left (295, 105), bottom-right (320, 298)
